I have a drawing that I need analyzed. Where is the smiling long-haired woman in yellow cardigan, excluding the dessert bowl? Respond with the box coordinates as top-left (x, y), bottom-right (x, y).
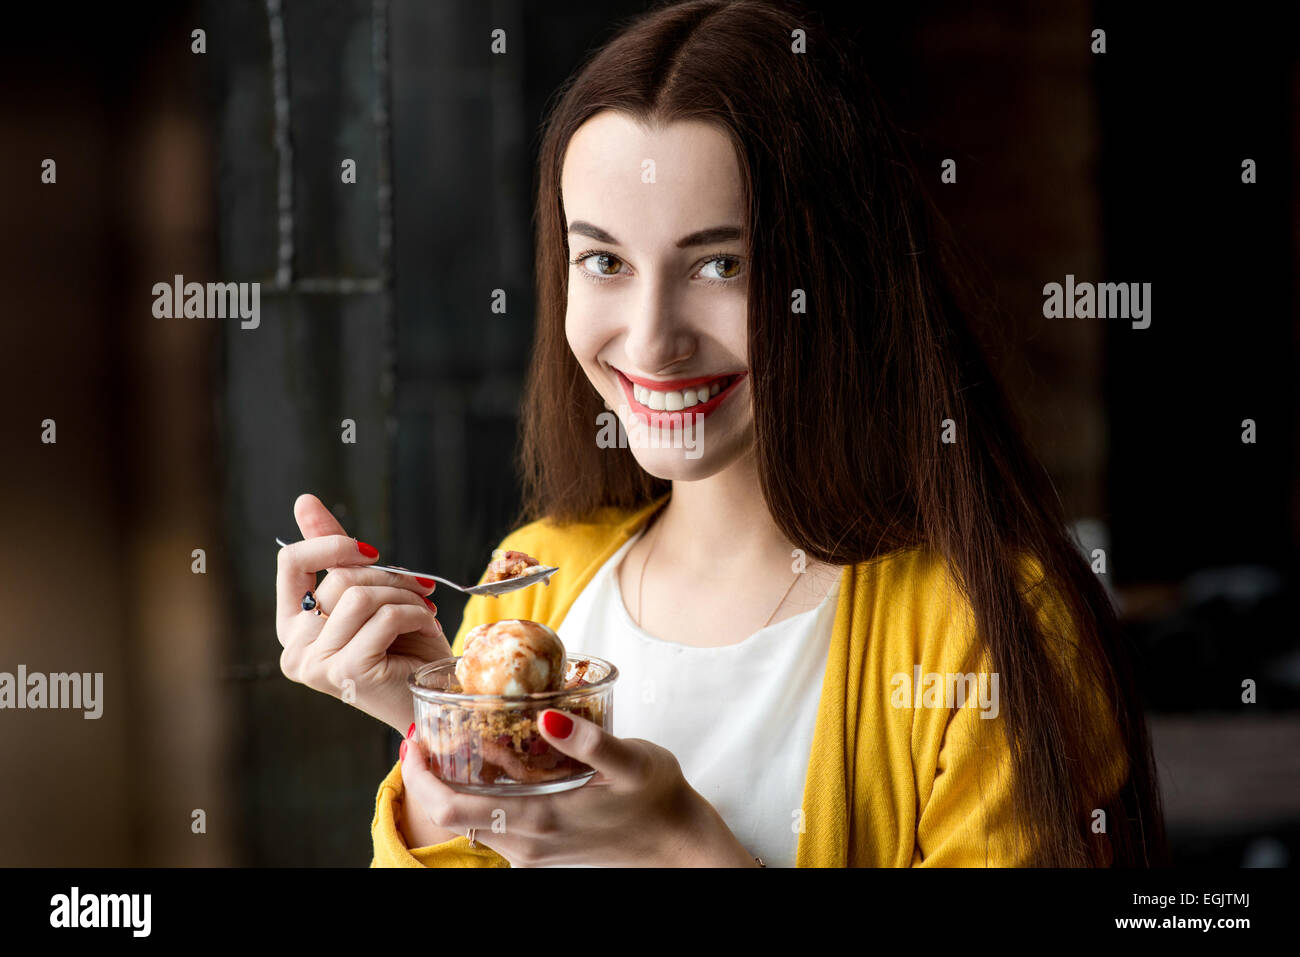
top-left (280, 0), bottom-right (1165, 866)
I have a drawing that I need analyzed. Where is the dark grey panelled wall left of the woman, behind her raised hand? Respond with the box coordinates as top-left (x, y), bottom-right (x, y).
top-left (204, 0), bottom-right (660, 863)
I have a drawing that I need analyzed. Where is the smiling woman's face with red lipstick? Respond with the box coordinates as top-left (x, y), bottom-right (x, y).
top-left (560, 111), bottom-right (754, 481)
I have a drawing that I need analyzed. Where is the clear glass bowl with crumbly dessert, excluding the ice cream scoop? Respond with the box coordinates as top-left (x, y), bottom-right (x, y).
top-left (410, 651), bottom-right (619, 794)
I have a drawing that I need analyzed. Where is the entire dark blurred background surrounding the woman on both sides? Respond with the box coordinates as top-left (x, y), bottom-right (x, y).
top-left (0, 0), bottom-right (1300, 866)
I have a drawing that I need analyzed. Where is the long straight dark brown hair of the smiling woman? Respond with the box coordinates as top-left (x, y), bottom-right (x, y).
top-left (520, 0), bottom-right (1167, 866)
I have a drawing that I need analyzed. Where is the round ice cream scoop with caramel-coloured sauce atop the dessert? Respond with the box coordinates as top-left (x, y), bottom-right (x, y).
top-left (456, 618), bottom-right (564, 694)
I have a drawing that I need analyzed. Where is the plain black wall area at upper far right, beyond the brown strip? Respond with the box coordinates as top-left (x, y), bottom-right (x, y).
top-left (1096, 3), bottom-right (1300, 581)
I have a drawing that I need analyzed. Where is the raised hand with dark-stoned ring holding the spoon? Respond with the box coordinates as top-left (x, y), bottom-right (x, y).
top-left (276, 495), bottom-right (451, 733)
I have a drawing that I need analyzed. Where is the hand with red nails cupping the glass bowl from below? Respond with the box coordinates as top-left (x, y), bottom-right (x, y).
top-left (402, 710), bottom-right (757, 867)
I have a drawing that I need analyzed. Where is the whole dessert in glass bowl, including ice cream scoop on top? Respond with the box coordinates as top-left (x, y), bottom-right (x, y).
top-left (411, 619), bottom-right (619, 794)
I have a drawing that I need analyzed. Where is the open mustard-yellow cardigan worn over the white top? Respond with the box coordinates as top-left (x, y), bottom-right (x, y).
top-left (371, 495), bottom-right (1127, 867)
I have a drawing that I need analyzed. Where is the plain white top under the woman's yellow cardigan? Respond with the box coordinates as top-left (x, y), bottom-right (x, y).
top-left (556, 529), bottom-right (840, 867)
